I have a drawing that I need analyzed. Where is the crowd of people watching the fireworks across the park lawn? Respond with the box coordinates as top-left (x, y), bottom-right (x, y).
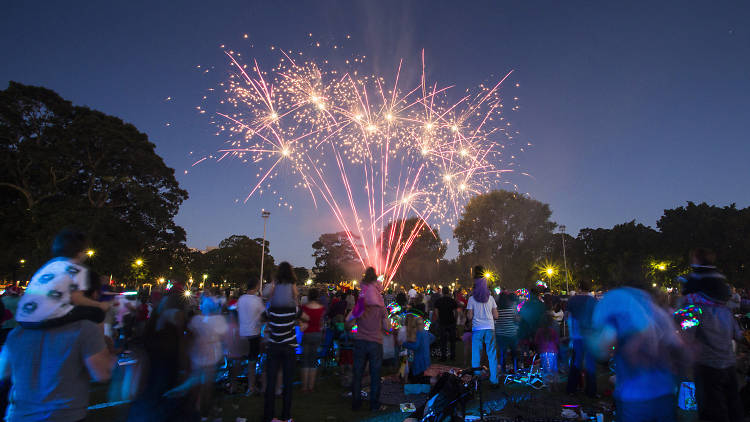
top-left (0, 230), bottom-right (746, 422)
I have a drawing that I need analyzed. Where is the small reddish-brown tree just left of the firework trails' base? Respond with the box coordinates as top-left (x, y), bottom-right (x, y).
top-left (312, 232), bottom-right (362, 283)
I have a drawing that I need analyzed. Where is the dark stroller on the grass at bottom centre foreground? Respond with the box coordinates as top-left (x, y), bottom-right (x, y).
top-left (406, 368), bottom-right (487, 422)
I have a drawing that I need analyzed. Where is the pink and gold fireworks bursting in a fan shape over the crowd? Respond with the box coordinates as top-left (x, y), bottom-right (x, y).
top-left (210, 47), bottom-right (512, 284)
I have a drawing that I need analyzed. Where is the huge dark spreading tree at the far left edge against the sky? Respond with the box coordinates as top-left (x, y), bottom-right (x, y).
top-left (0, 82), bottom-right (187, 276)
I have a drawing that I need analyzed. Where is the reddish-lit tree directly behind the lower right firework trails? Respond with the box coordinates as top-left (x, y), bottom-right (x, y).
top-left (379, 217), bottom-right (448, 284)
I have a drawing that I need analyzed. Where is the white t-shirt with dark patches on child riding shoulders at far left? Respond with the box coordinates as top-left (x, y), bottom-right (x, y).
top-left (16, 258), bottom-right (89, 322)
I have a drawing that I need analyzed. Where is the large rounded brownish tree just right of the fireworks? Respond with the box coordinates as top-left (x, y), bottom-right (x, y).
top-left (453, 190), bottom-right (556, 287)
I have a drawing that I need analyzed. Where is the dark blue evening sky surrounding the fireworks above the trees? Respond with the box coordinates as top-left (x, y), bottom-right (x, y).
top-left (0, 0), bottom-right (750, 266)
